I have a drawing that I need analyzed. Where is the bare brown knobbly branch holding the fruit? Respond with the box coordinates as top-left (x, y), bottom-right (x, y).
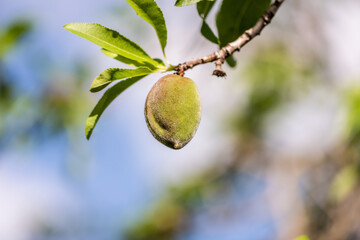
top-left (175, 0), bottom-right (285, 77)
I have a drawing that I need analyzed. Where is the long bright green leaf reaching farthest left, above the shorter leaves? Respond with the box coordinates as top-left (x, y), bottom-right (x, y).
top-left (64, 23), bottom-right (158, 66)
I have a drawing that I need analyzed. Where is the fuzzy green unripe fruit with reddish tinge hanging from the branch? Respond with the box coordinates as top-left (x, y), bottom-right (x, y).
top-left (145, 74), bottom-right (201, 149)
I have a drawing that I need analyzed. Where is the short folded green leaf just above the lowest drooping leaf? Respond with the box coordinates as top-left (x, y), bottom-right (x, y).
top-left (90, 67), bottom-right (154, 92)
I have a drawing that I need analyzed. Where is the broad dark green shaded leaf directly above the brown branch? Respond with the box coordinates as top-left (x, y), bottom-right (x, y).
top-left (216, 0), bottom-right (271, 47)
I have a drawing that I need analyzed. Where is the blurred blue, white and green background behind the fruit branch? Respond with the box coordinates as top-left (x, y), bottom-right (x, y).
top-left (0, 0), bottom-right (360, 240)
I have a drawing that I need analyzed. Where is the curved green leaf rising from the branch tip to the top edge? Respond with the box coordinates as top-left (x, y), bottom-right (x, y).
top-left (126, 0), bottom-right (167, 56)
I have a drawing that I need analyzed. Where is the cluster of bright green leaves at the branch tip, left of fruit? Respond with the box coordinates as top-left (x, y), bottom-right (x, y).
top-left (64, 0), bottom-right (169, 139)
